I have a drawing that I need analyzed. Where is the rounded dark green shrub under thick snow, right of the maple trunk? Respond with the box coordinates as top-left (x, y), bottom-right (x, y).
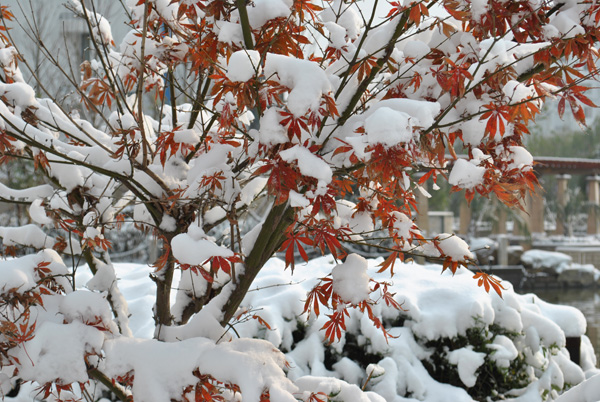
top-left (236, 257), bottom-right (599, 402)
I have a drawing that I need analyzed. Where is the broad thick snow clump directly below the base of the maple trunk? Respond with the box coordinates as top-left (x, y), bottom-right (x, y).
top-left (104, 338), bottom-right (296, 402)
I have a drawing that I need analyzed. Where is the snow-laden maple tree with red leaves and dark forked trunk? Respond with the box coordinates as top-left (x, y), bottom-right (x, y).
top-left (0, 0), bottom-right (600, 401)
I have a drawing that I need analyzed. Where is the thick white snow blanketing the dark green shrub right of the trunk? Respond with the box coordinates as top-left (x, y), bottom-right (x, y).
top-left (236, 257), bottom-right (597, 402)
